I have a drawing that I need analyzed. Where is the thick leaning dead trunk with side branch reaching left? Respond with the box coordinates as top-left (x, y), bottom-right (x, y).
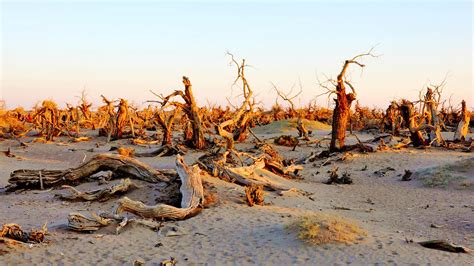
top-left (160, 76), bottom-right (206, 149)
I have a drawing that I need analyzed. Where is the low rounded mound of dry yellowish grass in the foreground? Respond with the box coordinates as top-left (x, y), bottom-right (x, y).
top-left (287, 213), bottom-right (367, 245)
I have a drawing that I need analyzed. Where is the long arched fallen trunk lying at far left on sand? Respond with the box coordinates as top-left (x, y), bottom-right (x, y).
top-left (8, 154), bottom-right (170, 189)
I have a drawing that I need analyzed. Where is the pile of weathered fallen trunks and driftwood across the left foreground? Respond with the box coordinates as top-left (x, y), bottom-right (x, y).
top-left (3, 136), bottom-right (302, 232)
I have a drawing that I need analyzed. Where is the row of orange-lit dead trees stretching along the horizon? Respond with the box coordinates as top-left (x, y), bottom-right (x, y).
top-left (2, 49), bottom-right (471, 152)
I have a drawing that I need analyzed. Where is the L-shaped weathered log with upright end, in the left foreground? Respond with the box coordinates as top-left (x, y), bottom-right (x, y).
top-left (116, 155), bottom-right (204, 220)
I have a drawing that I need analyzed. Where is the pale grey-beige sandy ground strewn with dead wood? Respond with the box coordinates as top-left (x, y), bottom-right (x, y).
top-left (0, 128), bottom-right (474, 265)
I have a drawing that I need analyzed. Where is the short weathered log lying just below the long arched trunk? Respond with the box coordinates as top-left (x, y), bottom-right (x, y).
top-left (58, 178), bottom-right (139, 201)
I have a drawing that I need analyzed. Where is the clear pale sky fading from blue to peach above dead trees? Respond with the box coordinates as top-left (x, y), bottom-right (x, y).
top-left (0, 1), bottom-right (474, 108)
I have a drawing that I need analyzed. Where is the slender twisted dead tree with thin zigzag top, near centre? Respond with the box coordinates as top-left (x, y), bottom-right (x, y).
top-left (216, 53), bottom-right (253, 150)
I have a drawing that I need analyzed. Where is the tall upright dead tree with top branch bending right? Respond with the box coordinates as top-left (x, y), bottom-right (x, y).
top-left (320, 48), bottom-right (376, 152)
